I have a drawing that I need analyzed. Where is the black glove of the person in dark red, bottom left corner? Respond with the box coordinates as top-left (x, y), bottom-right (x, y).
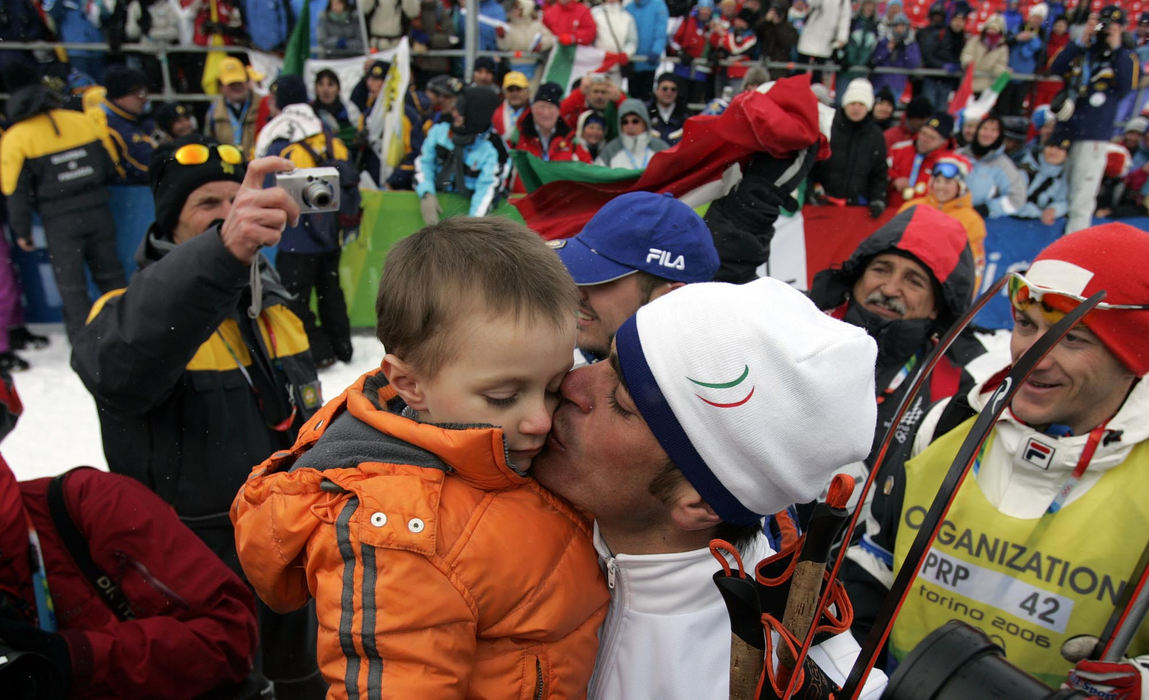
top-left (0, 617), bottom-right (71, 699)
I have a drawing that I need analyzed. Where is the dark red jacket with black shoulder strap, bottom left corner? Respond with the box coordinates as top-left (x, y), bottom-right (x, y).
top-left (0, 459), bottom-right (256, 698)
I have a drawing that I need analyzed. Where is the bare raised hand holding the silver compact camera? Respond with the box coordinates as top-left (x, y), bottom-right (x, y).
top-left (219, 156), bottom-right (299, 264)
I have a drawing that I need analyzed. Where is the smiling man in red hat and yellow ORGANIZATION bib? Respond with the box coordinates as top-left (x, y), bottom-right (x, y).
top-left (849, 223), bottom-right (1149, 700)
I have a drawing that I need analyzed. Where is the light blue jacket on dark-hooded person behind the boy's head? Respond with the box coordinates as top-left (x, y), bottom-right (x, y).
top-left (415, 122), bottom-right (499, 216)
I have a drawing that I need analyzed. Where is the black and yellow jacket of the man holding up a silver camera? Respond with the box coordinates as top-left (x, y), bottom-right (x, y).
top-left (72, 226), bottom-right (322, 526)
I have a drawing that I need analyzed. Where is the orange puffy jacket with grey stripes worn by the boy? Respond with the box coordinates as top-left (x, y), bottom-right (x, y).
top-left (231, 370), bottom-right (609, 699)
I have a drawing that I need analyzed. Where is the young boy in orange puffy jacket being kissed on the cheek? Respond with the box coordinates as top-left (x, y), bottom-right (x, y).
top-left (231, 217), bottom-right (608, 698)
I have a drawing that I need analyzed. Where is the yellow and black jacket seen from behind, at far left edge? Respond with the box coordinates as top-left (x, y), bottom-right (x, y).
top-left (0, 85), bottom-right (113, 239)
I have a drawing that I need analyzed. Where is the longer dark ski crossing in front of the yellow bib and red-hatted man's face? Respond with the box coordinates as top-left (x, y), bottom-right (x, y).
top-left (841, 291), bottom-right (1105, 700)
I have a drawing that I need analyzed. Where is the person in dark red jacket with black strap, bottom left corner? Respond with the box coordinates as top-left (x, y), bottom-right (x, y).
top-left (0, 372), bottom-right (256, 700)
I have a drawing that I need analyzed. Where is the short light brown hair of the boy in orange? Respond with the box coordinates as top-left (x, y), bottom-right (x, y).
top-left (375, 216), bottom-right (578, 376)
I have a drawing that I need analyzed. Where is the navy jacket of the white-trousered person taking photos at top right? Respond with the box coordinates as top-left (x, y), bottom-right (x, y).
top-left (1049, 41), bottom-right (1140, 141)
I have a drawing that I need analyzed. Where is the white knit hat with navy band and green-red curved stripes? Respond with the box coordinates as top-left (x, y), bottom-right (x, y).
top-left (615, 278), bottom-right (877, 523)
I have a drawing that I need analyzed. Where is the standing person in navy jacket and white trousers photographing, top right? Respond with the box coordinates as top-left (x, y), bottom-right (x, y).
top-left (1049, 5), bottom-right (1138, 233)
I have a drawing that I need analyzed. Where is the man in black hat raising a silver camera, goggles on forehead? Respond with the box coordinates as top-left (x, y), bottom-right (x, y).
top-left (71, 134), bottom-right (325, 699)
